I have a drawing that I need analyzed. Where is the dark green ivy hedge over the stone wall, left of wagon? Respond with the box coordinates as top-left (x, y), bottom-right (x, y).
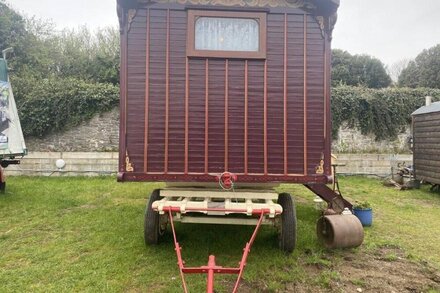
top-left (12, 77), bottom-right (119, 137)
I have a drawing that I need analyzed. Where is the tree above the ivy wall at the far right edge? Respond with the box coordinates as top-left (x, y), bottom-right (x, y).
top-left (399, 44), bottom-right (440, 88)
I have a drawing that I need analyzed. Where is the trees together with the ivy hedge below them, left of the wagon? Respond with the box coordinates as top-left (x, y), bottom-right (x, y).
top-left (0, 0), bottom-right (119, 136)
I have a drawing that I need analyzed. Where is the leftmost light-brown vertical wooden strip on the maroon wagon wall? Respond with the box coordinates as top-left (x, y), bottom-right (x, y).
top-left (144, 9), bottom-right (150, 173)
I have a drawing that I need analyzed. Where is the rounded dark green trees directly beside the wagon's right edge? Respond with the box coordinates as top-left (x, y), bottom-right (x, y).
top-left (332, 49), bottom-right (391, 88)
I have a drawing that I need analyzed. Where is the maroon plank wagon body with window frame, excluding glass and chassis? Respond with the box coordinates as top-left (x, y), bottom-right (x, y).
top-left (119, 0), bottom-right (337, 185)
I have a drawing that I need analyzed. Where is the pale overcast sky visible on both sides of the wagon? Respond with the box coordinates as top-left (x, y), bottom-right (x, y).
top-left (7, 0), bottom-right (440, 65)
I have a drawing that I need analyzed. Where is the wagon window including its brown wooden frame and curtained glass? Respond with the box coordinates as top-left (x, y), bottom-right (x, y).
top-left (187, 10), bottom-right (266, 58)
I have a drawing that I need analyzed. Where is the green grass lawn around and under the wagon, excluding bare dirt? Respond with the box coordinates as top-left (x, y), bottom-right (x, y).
top-left (0, 177), bottom-right (440, 292)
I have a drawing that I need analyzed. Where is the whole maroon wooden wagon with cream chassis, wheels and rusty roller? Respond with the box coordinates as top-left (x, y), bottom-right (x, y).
top-left (118, 0), bottom-right (363, 288)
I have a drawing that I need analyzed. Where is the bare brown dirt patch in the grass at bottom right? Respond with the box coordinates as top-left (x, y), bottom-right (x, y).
top-left (232, 247), bottom-right (440, 293)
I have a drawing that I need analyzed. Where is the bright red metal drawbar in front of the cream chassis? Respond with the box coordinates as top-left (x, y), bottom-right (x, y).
top-left (163, 206), bottom-right (270, 293)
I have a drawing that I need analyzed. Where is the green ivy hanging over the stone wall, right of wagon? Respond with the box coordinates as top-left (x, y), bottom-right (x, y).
top-left (331, 86), bottom-right (440, 140)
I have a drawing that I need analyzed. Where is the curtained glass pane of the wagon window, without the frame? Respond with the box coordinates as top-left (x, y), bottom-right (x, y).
top-left (195, 17), bottom-right (260, 52)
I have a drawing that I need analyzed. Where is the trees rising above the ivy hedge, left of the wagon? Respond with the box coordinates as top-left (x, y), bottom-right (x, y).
top-left (0, 0), bottom-right (119, 84)
